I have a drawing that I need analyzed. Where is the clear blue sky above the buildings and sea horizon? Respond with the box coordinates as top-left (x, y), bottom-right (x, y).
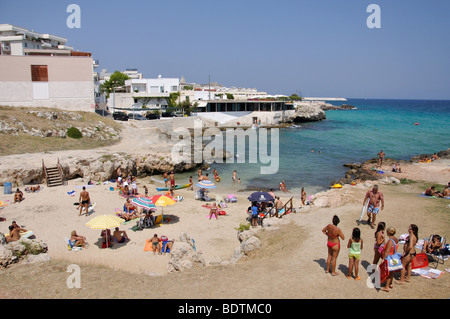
top-left (0, 0), bottom-right (450, 99)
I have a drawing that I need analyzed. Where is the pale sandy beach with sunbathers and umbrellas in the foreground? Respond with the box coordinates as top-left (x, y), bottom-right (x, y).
top-left (0, 123), bottom-right (450, 299)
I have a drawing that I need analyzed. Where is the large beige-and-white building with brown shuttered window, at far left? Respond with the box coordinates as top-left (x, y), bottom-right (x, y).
top-left (0, 24), bottom-right (95, 111)
